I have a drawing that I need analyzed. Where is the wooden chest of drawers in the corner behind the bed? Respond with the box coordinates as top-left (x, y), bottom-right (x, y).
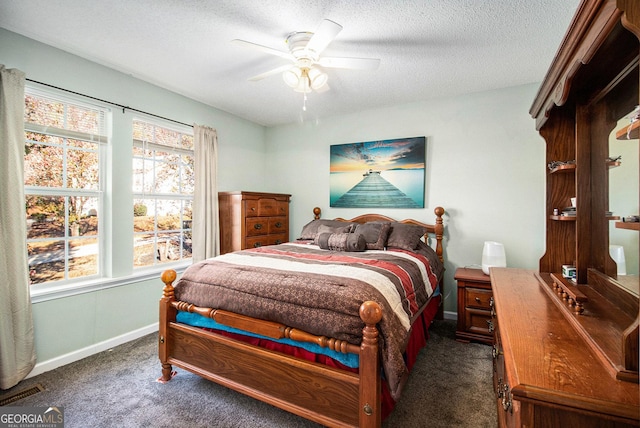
top-left (218, 191), bottom-right (291, 254)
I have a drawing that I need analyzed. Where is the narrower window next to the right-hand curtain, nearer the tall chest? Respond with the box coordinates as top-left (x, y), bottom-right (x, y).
top-left (133, 120), bottom-right (194, 268)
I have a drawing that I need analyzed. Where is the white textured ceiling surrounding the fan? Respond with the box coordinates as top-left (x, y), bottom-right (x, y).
top-left (0, 0), bottom-right (579, 126)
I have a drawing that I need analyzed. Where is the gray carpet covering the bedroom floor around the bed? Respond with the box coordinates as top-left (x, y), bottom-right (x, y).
top-left (0, 320), bottom-right (497, 428)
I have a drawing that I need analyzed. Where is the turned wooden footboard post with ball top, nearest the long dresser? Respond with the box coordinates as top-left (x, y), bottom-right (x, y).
top-left (359, 301), bottom-right (382, 428)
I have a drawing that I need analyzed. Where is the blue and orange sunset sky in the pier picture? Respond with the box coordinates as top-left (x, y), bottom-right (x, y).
top-left (330, 137), bottom-right (425, 172)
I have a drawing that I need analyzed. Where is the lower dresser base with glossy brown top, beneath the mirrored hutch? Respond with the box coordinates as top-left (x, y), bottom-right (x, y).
top-left (491, 268), bottom-right (640, 428)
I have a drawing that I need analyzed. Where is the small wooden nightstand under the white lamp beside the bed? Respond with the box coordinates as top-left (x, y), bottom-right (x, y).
top-left (454, 268), bottom-right (493, 345)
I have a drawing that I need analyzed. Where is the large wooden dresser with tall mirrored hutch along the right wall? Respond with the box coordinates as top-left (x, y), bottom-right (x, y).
top-left (491, 0), bottom-right (640, 427)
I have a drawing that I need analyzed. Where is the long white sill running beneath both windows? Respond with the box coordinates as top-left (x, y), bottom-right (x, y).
top-left (31, 261), bottom-right (191, 304)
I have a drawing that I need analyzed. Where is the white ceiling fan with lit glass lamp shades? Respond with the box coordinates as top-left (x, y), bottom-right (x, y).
top-left (231, 19), bottom-right (380, 94)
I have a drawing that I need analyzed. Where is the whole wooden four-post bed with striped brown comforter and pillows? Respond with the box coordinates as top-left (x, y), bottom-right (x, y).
top-left (158, 207), bottom-right (444, 427)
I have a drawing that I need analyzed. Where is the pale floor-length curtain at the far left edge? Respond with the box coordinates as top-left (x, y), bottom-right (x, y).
top-left (0, 64), bottom-right (36, 389)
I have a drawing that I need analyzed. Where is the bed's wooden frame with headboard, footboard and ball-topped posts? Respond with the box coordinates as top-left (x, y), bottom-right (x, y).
top-left (158, 207), bottom-right (444, 428)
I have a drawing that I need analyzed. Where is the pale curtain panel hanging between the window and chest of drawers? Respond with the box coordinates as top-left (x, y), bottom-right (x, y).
top-left (192, 125), bottom-right (220, 263)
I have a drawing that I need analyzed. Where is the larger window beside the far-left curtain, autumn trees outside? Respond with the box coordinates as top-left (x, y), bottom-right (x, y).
top-left (24, 88), bottom-right (109, 284)
